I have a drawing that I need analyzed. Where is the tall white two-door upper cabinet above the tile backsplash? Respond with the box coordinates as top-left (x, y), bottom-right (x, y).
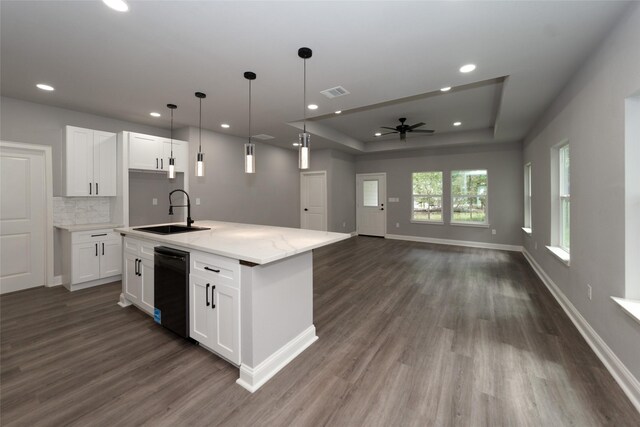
top-left (63, 126), bottom-right (117, 196)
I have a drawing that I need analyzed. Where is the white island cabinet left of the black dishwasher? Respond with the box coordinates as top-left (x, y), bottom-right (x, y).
top-left (122, 237), bottom-right (155, 315)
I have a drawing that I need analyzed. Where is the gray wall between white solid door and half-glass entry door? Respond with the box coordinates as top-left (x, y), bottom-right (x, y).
top-left (309, 150), bottom-right (356, 233)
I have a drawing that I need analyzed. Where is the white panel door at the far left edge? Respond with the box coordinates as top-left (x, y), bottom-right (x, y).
top-left (0, 145), bottom-right (48, 293)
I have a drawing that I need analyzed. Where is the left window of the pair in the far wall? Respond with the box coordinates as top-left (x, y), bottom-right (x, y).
top-left (411, 172), bottom-right (442, 222)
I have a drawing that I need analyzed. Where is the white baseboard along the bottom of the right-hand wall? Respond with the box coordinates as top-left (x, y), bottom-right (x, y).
top-left (522, 249), bottom-right (640, 412)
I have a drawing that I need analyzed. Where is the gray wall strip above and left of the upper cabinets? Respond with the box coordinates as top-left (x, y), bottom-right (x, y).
top-left (0, 94), bottom-right (169, 196)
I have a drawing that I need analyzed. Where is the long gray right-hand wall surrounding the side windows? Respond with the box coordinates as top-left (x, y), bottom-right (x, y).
top-left (524, 4), bottom-right (640, 379)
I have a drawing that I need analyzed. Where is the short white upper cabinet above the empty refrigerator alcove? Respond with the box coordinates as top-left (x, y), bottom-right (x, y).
top-left (129, 133), bottom-right (189, 172)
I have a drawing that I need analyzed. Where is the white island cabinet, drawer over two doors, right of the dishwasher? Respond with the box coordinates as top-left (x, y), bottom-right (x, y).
top-left (189, 252), bottom-right (240, 365)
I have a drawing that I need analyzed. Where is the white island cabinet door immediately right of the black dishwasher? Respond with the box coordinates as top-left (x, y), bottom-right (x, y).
top-left (189, 274), bottom-right (214, 348)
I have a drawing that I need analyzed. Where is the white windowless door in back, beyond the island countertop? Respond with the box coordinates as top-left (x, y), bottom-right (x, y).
top-left (300, 171), bottom-right (327, 231)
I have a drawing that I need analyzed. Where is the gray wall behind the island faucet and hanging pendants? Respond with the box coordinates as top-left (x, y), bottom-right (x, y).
top-left (176, 127), bottom-right (300, 227)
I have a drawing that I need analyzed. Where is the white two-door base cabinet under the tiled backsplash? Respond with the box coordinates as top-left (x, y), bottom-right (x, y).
top-left (62, 229), bottom-right (122, 291)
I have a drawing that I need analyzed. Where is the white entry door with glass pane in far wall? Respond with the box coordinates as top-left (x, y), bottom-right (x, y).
top-left (356, 173), bottom-right (387, 241)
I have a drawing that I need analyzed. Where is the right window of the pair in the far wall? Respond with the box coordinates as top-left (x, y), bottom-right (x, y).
top-left (451, 170), bottom-right (488, 224)
